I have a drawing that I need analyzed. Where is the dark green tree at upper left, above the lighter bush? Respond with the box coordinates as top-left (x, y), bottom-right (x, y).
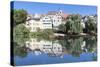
top-left (12, 9), bottom-right (27, 25)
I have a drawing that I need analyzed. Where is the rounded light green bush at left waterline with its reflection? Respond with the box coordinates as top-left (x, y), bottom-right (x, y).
top-left (13, 24), bottom-right (29, 45)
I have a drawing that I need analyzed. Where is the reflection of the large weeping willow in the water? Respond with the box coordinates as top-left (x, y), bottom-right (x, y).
top-left (60, 37), bottom-right (83, 56)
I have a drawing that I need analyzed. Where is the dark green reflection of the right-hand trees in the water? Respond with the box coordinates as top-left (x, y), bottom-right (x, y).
top-left (59, 36), bottom-right (97, 57)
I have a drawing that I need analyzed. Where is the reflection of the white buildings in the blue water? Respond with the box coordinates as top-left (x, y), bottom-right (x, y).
top-left (26, 38), bottom-right (63, 57)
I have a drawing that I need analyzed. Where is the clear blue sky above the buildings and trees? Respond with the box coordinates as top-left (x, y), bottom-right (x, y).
top-left (13, 1), bottom-right (97, 15)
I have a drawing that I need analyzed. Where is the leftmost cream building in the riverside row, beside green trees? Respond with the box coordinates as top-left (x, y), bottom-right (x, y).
top-left (25, 14), bottom-right (43, 32)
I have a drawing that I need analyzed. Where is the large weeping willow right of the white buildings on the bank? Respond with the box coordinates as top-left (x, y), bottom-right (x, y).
top-left (65, 14), bottom-right (83, 34)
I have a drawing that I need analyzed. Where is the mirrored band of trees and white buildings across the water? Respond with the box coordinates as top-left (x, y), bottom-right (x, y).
top-left (14, 36), bottom-right (97, 60)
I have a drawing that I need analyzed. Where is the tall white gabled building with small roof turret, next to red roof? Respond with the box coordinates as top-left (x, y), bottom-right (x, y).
top-left (47, 10), bottom-right (68, 29)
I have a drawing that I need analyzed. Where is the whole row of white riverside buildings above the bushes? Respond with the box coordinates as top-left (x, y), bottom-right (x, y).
top-left (25, 10), bottom-right (68, 32)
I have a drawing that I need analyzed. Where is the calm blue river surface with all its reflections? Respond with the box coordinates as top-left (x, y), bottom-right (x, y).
top-left (14, 36), bottom-right (97, 66)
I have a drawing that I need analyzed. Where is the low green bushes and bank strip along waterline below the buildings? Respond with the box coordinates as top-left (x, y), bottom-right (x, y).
top-left (29, 29), bottom-right (97, 39)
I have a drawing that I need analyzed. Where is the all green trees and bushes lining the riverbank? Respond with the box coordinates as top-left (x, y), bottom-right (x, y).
top-left (11, 9), bottom-right (97, 44)
